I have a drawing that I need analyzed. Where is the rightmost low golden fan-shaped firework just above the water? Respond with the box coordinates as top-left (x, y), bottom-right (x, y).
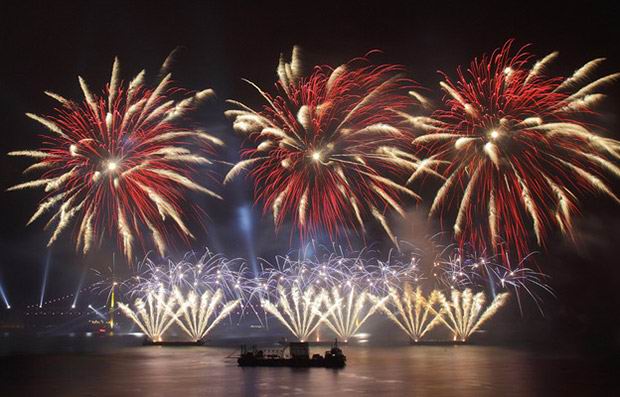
top-left (437, 288), bottom-right (509, 342)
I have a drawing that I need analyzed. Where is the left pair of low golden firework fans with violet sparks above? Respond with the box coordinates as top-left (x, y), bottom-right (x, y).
top-left (117, 249), bottom-right (250, 340)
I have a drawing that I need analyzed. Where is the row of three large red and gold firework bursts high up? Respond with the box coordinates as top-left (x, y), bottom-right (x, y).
top-left (9, 41), bottom-right (620, 263)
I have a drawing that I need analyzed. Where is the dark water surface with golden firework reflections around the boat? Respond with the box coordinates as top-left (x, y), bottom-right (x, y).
top-left (0, 339), bottom-right (620, 397)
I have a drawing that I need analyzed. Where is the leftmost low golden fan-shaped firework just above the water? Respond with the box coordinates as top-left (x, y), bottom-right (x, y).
top-left (118, 288), bottom-right (179, 342)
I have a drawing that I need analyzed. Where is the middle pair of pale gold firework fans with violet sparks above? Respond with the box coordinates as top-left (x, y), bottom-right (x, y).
top-left (248, 243), bottom-right (416, 334)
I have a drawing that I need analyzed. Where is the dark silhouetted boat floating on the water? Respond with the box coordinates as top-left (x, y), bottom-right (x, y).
top-left (237, 341), bottom-right (347, 368)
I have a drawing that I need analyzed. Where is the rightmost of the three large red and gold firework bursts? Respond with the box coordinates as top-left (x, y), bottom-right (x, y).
top-left (392, 41), bottom-right (620, 258)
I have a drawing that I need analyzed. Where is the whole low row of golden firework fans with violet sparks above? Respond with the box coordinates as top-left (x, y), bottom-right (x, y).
top-left (106, 245), bottom-right (551, 341)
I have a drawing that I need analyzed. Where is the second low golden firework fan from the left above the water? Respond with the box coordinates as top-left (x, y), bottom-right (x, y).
top-left (174, 289), bottom-right (240, 341)
